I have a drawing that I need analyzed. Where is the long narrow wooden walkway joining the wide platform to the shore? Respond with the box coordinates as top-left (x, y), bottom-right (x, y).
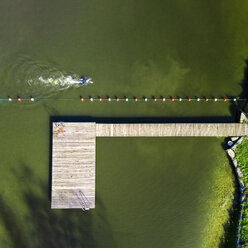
top-left (96, 123), bottom-right (248, 137)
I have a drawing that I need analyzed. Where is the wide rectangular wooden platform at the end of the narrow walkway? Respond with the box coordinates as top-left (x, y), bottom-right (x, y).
top-left (51, 122), bottom-right (96, 208)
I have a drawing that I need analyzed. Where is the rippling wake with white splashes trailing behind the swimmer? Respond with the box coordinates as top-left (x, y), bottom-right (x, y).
top-left (5, 57), bottom-right (92, 98)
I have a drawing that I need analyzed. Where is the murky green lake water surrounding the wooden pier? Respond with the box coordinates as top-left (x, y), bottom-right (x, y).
top-left (0, 0), bottom-right (248, 248)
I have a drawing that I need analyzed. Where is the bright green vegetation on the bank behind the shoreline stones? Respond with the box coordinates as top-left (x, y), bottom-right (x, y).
top-left (235, 139), bottom-right (248, 247)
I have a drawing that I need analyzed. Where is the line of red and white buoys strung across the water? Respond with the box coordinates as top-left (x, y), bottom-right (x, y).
top-left (3, 97), bottom-right (248, 102)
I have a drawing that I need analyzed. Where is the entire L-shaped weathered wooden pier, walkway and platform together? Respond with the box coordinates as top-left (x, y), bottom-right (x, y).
top-left (51, 122), bottom-right (248, 209)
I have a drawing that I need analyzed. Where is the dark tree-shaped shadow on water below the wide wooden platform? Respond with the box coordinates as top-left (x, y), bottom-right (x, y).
top-left (0, 164), bottom-right (114, 248)
